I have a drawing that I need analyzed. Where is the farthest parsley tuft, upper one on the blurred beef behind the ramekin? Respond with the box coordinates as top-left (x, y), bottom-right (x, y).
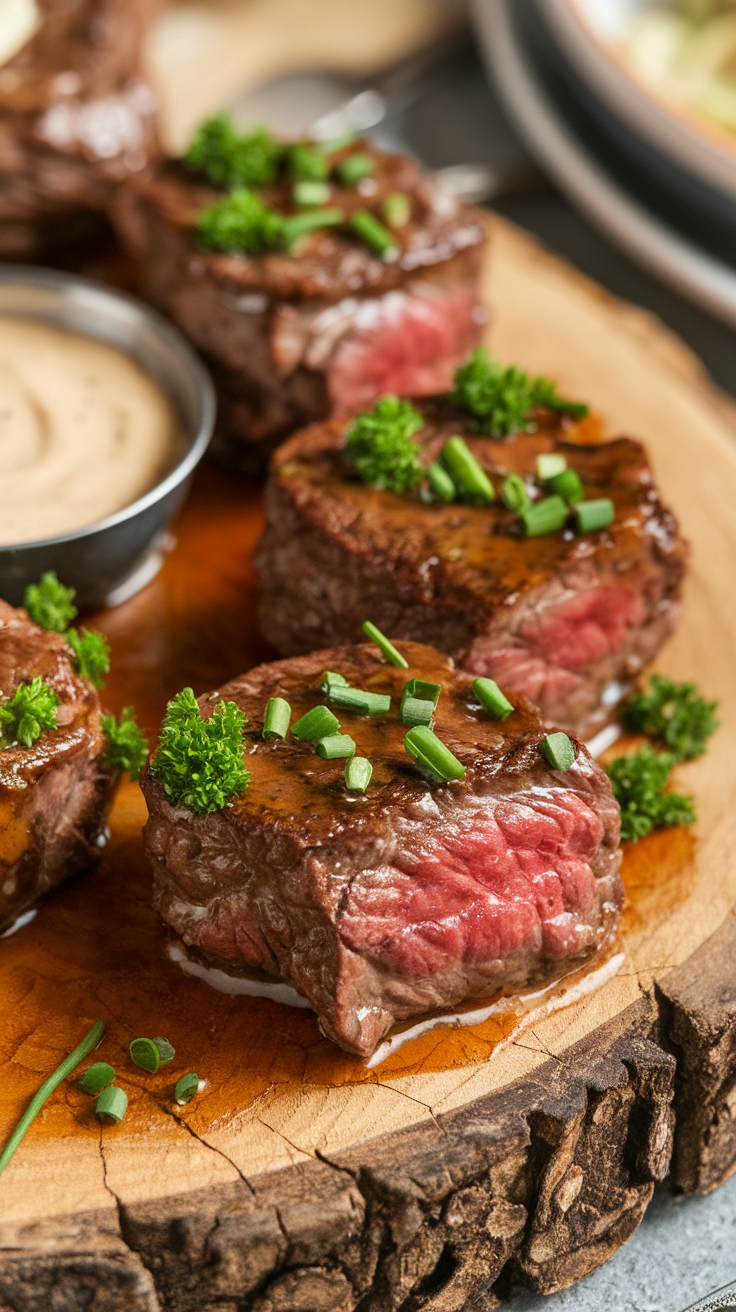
top-left (184, 114), bottom-right (283, 186)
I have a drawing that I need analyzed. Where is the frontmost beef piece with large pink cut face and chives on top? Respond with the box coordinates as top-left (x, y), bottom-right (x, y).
top-left (143, 643), bottom-right (623, 1057)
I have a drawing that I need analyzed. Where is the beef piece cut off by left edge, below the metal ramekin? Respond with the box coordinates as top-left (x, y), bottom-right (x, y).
top-left (0, 601), bottom-right (119, 934)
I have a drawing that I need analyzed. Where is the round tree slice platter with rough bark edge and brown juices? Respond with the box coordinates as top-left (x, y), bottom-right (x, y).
top-left (0, 219), bottom-right (736, 1312)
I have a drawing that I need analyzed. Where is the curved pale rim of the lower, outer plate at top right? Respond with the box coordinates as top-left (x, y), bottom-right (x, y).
top-left (472, 0), bottom-right (736, 327)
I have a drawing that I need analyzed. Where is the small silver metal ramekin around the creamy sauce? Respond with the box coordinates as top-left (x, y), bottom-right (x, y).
top-left (0, 265), bottom-right (215, 607)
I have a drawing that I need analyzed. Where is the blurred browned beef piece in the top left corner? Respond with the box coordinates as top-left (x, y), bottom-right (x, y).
top-left (0, 0), bottom-right (160, 255)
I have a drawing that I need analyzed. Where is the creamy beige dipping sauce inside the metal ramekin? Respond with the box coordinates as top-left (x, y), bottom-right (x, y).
top-left (0, 316), bottom-right (180, 546)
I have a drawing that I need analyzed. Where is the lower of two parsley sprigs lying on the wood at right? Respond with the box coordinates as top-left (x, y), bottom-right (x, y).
top-left (606, 743), bottom-right (695, 842)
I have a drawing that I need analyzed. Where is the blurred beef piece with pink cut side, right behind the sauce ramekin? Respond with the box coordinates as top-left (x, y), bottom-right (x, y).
top-left (117, 143), bottom-right (485, 463)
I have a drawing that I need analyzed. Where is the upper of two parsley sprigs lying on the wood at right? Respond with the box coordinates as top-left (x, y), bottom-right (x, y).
top-left (623, 674), bottom-right (719, 761)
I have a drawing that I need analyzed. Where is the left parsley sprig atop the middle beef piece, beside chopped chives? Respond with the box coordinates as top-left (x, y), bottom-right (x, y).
top-left (345, 396), bottom-right (424, 492)
